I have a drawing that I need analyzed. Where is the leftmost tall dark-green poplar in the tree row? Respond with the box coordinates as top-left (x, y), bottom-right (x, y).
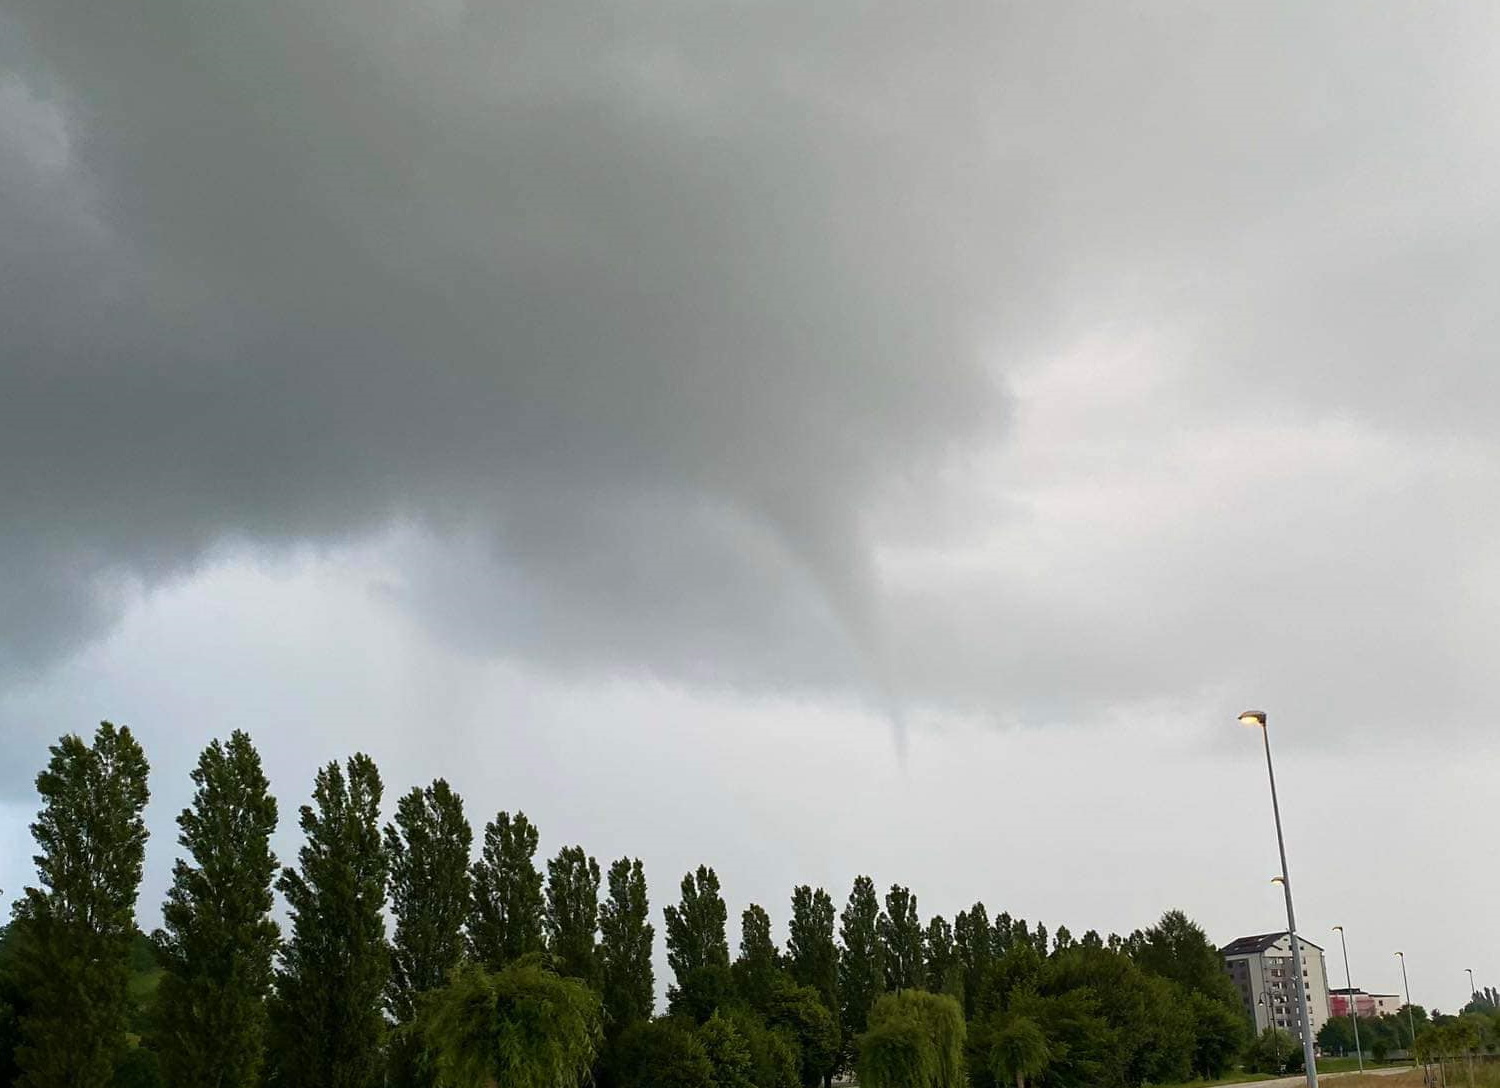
top-left (12, 722), bottom-right (150, 1088)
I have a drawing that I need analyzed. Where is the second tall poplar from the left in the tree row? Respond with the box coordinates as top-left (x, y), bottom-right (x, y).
top-left (156, 729), bottom-right (281, 1088)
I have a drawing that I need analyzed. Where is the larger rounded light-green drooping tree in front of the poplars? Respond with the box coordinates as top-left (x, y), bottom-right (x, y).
top-left (419, 960), bottom-right (603, 1088)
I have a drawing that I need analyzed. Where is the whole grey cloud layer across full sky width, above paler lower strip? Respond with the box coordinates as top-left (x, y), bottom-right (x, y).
top-left (0, 0), bottom-right (1500, 738)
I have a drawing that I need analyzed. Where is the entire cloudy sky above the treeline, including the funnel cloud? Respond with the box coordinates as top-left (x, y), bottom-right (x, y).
top-left (0, 0), bottom-right (1500, 1010)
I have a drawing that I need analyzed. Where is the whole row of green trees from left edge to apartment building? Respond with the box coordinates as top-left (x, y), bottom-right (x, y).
top-left (0, 723), bottom-right (1248, 1088)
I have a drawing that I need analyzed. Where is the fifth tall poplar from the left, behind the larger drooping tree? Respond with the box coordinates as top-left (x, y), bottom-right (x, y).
top-left (468, 812), bottom-right (546, 971)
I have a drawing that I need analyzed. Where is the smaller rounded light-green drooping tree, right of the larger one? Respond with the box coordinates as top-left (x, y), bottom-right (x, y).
top-left (860, 989), bottom-right (965, 1088)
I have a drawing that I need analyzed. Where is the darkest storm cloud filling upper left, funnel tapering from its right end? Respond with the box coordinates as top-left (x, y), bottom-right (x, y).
top-left (0, 3), bottom-right (1017, 687)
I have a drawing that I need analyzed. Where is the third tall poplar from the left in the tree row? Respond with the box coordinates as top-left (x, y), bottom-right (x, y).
top-left (272, 753), bottom-right (390, 1088)
